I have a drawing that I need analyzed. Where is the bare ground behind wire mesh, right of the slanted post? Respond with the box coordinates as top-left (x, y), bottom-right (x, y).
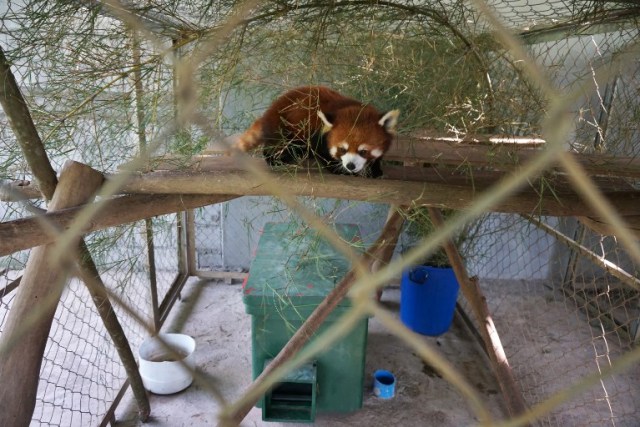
top-left (483, 280), bottom-right (640, 427)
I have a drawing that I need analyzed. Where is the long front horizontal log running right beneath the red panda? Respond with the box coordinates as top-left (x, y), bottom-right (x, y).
top-left (117, 157), bottom-right (640, 216)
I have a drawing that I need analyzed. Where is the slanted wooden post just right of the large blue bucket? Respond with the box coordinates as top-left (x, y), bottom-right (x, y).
top-left (429, 208), bottom-right (527, 417)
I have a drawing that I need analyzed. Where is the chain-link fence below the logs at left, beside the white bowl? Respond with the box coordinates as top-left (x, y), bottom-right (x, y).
top-left (0, 215), bottom-right (185, 426)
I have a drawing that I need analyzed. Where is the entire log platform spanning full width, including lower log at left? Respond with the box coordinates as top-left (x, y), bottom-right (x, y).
top-left (0, 136), bottom-right (640, 260)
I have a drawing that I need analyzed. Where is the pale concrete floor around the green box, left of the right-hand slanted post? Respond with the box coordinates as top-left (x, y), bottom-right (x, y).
top-left (115, 280), bottom-right (504, 427)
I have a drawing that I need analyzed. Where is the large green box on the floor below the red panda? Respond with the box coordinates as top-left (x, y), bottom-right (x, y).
top-left (243, 223), bottom-right (368, 421)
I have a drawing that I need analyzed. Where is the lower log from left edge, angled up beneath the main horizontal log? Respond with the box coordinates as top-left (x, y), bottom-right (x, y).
top-left (0, 194), bottom-right (237, 256)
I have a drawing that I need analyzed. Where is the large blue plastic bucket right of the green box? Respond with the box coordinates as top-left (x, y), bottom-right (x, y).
top-left (400, 266), bottom-right (459, 336)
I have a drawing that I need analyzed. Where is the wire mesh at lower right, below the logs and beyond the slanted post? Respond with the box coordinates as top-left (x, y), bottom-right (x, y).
top-left (470, 215), bottom-right (639, 425)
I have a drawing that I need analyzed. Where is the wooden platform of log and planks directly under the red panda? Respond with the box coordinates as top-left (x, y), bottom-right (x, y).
top-left (117, 136), bottom-right (640, 236)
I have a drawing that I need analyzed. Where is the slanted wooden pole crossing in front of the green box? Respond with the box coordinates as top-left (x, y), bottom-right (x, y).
top-left (219, 207), bottom-right (404, 427)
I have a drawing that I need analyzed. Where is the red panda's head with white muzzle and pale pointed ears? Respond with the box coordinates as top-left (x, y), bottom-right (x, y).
top-left (318, 107), bottom-right (399, 174)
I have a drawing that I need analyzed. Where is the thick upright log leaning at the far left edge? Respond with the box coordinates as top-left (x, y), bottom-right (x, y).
top-left (0, 162), bottom-right (103, 426)
